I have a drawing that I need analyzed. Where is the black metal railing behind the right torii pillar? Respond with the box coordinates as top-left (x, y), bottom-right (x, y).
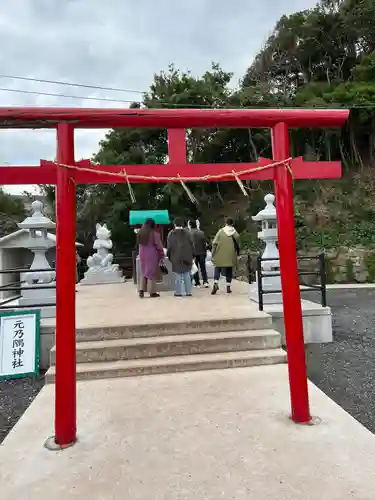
top-left (248, 253), bottom-right (327, 311)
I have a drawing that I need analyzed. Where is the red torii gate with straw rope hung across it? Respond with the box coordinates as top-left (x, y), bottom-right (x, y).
top-left (0, 108), bottom-right (349, 448)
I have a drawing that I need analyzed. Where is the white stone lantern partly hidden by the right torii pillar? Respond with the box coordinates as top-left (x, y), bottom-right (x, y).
top-left (250, 193), bottom-right (282, 304)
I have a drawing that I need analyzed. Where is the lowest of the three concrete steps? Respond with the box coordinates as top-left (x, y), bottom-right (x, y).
top-left (46, 349), bottom-right (286, 383)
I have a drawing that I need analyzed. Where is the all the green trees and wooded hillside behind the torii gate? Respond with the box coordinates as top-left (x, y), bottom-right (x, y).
top-left (33, 0), bottom-right (375, 251)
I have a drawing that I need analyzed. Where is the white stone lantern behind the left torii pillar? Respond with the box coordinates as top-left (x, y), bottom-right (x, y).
top-left (18, 200), bottom-right (56, 317)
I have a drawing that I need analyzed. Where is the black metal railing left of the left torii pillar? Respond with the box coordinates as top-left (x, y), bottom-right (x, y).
top-left (0, 267), bottom-right (56, 310)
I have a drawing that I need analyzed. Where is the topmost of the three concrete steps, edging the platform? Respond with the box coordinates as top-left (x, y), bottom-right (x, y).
top-left (76, 311), bottom-right (272, 342)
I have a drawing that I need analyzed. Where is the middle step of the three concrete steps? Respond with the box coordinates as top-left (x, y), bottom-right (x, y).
top-left (51, 330), bottom-right (281, 365)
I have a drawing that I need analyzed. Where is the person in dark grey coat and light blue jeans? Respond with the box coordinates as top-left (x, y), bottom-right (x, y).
top-left (167, 220), bottom-right (194, 297)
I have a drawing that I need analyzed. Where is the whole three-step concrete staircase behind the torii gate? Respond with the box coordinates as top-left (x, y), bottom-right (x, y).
top-left (46, 313), bottom-right (286, 383)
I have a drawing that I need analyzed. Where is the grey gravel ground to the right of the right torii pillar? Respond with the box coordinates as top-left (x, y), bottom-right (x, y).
top-left (307, 288), bottom-right (375, 432)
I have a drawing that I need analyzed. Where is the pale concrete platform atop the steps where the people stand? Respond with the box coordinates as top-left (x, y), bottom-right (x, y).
top-left (43, 281), bottom-right (265, 328)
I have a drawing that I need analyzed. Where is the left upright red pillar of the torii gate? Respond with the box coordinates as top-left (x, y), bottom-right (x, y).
top-left (55, 122), bottom-right (76, 447)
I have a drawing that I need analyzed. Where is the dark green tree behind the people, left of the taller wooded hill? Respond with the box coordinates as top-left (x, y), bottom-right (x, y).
top-left (84, 64), bottom-right (253, 251)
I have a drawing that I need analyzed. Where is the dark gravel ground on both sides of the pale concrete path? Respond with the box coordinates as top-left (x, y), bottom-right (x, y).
top-left (0, 289), bottom-right (375, 443)
